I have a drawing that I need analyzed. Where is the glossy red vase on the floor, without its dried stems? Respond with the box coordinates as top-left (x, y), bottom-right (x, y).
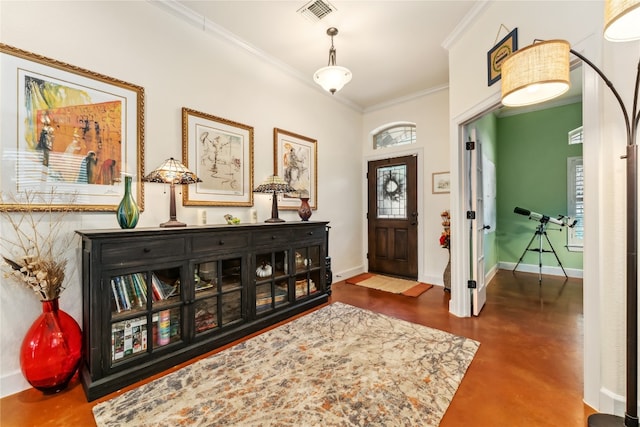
top-left (20, 298), bottom-right (82, 393)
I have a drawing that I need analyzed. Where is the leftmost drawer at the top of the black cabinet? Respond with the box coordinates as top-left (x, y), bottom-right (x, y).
top-left (101, 237), bottom-right (185, 265)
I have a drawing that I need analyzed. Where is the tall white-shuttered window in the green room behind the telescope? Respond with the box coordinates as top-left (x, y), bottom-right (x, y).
top-left (567, 156), bottom-right (584, 251)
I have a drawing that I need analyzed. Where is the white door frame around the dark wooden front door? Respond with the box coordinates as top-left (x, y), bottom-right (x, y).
top-left (361, 147), bottom-right (426, 282)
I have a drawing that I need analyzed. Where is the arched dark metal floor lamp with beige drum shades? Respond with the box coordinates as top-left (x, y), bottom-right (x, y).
top-left (501, 0), bottom-right (640, 427)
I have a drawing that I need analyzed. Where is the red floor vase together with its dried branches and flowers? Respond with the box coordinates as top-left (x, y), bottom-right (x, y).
top-left (0, 189), bottom-right (82, 393)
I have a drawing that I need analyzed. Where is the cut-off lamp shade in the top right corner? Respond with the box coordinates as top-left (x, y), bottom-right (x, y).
top-left (604, 0), bottom-right (640, 42)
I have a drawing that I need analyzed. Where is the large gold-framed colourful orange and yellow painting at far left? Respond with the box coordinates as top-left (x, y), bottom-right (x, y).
top-left (0, 43), bottom-right (144, 211)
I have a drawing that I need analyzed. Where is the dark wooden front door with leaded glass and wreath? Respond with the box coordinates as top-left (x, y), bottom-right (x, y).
top-left (367, 156), bottom-right (418, 279)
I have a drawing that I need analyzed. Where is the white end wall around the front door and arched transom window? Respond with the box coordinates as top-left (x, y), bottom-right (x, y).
top-left (362, 88), bottom-right (450, 285)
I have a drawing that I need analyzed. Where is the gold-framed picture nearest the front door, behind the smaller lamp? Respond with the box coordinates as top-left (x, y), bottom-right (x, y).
top-left (273, 128), bottom-right (318, 210)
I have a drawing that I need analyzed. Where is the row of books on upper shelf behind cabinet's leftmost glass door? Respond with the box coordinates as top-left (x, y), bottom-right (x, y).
top-left (111, 273), bottom-right (178, 313)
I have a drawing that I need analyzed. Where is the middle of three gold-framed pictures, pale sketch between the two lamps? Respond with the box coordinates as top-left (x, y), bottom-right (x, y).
top-left (182, 108), bottom-right (253, 206)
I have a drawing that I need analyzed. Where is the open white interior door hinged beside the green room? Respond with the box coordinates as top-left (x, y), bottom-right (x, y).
top-left (466, 128), bottom-right (487, 316)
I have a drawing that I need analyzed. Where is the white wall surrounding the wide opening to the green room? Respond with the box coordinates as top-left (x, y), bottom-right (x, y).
top-left (449, 1), bottom-right (640, 414)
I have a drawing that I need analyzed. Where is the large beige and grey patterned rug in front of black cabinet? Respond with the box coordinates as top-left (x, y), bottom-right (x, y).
top-left (93, 303), bottom-right (480, 427)
